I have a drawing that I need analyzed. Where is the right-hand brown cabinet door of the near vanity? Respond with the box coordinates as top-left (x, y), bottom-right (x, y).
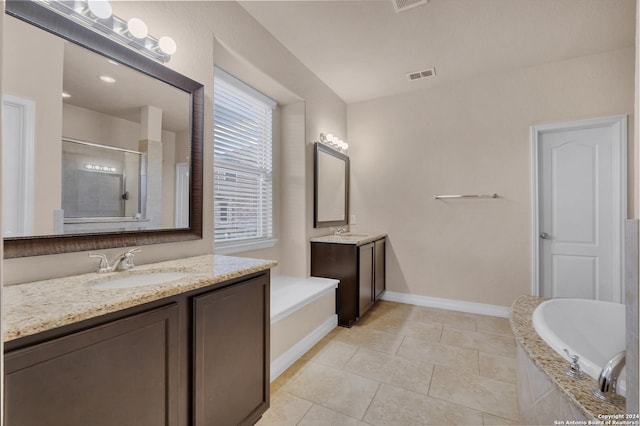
top-left (193, 275), bottom-right (270, 426)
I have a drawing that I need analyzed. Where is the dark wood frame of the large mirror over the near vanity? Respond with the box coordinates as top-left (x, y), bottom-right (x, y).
top-left (4, 0), bottom-right (204, 259)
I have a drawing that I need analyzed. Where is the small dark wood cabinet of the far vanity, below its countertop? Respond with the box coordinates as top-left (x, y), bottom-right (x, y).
top-left (311, 237), bottom-right (386, 327)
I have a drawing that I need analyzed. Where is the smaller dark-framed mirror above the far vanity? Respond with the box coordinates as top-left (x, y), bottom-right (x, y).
top-left (313, 142), bottom-right (349, 228)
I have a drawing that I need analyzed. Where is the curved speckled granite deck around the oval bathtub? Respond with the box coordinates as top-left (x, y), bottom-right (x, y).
top-left (511, 296), bottom-right (626, 421)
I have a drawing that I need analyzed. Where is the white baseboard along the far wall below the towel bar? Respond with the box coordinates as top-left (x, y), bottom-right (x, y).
top-left (382, 291), bottom-right (511, 318)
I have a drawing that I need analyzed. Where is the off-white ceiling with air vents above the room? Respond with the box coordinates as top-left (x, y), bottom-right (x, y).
top-left (240, 0), bottom-right (635, 103)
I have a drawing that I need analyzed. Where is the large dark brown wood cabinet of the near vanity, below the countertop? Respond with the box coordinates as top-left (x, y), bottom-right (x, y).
top-left (4, 272), bottom-right (270, 426)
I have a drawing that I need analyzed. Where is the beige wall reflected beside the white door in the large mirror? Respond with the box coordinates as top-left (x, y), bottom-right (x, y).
top-left (2, 18), bottom-right (64, 235)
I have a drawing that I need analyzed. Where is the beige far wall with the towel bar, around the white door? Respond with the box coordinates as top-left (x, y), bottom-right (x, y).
top-left (348, 48), bottom-right (635, 306)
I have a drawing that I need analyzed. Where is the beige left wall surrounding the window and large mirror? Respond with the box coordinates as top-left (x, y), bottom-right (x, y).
top-left (2, 1), bottom-right (346, 284)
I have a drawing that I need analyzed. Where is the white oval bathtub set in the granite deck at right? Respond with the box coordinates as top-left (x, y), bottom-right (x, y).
top-left (531, 299), bottom-right (626, 395)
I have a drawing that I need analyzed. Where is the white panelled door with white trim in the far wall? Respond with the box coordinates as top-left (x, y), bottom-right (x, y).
top-left (533, 117), bottom-right (627, 302)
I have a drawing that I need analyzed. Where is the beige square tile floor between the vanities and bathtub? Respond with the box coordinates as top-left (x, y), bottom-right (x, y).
top-left (257, 301), bottom-right (519, 426)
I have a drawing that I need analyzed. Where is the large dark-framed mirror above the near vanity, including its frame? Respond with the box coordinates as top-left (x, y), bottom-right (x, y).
top-left (2, 0), bottom-right (204, 258)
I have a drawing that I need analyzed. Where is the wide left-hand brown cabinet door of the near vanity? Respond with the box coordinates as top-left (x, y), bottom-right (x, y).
top-left (4, 304), bottom-right (179, 426)
